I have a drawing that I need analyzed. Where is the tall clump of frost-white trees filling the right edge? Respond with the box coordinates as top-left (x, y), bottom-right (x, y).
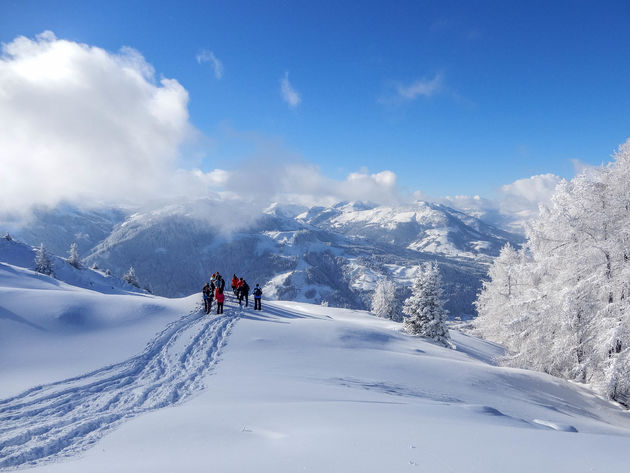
top-left (477, 141), bottom-right (630, 405)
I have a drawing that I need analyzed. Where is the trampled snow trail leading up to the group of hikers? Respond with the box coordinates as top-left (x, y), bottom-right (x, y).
top-left (0, 308), bottom-right (238, 468)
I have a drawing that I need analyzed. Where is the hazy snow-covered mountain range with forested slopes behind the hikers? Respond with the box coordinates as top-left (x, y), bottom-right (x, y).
top-left (7, 200), bottom-right (520, 316)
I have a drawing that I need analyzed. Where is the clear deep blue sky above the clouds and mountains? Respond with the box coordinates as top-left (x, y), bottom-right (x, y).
top-left (0, 0), bottom-right (630, 196)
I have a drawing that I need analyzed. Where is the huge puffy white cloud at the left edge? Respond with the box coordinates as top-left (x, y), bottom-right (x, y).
top-left (0, 32), bottom-right (192, 218)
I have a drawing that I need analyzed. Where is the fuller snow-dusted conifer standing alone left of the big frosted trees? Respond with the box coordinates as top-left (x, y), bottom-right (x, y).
top-left (402, 263), bottom-right (453, 347)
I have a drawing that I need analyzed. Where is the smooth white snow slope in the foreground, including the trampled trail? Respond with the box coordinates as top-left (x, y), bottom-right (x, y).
top-left (0, 264), bottom-right (630, 473)
